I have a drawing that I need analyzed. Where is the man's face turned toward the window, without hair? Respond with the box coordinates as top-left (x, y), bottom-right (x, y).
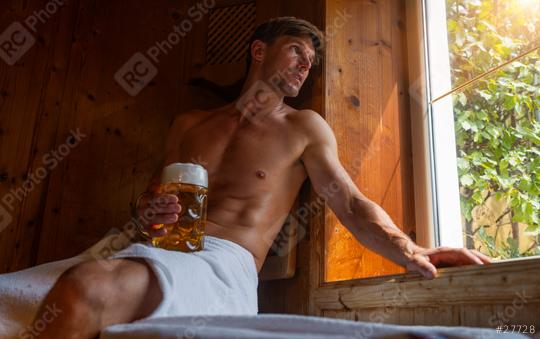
top-left (263, 35), bottom-right (315, 97)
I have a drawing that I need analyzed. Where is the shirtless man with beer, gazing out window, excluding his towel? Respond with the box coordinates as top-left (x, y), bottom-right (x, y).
top-left (31, 18), bottom-right (490, 338)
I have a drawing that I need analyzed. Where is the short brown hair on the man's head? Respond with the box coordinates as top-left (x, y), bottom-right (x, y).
top-left (246, 16), bottom-right (324, 70)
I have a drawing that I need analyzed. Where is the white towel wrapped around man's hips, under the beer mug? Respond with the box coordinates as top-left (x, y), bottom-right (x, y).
top-left (110, 236), bottom-right (259, 318)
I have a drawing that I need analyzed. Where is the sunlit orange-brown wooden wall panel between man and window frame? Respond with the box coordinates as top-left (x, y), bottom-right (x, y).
top-left (325, 0), bottom-right (415, 281)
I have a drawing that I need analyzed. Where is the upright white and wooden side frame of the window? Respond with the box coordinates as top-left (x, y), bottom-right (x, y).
top-left (407, 0), bottom-right (464, 247)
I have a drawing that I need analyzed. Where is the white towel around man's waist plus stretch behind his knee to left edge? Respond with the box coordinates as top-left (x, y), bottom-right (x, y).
top-left (0, 232), bottom-right (258, 338)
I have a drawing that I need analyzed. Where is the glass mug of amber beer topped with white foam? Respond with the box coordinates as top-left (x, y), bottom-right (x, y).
top-left (152, 162), bottom-right (208, 252)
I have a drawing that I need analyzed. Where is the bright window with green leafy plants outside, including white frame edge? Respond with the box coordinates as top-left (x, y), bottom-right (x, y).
top-left (424, 0), bottom-right (540, 259)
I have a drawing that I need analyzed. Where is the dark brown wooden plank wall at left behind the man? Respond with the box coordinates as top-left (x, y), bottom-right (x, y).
top-left (0, 0), bottom-right (231, 272)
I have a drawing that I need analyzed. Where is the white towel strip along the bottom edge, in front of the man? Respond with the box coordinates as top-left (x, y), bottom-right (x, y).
top-left (100, 314), bottom-right (527, 339)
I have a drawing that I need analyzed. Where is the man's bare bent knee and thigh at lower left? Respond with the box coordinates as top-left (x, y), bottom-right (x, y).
top-left (32, 259), bottom-right (163, 338)
